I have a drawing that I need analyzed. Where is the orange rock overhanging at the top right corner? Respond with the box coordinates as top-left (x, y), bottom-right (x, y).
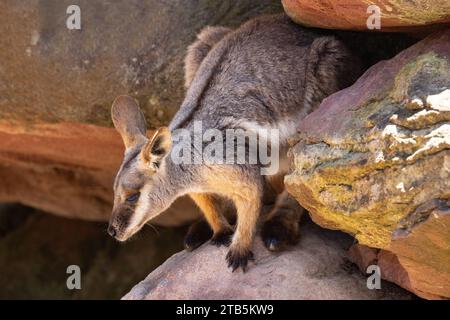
top-left (282, 0), bottom-right (450, 32)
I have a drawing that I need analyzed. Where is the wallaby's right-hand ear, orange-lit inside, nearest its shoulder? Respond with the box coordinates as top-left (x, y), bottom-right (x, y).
top-left (141, 127), bottom-right (172, 171)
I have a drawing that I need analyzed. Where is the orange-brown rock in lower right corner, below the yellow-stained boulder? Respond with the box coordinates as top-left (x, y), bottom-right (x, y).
top-left (349, 208), bottom-right (450, 299)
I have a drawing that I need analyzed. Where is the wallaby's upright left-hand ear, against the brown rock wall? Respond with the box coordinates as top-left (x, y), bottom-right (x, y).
top-left (111, 96), bottom-right (146, 149)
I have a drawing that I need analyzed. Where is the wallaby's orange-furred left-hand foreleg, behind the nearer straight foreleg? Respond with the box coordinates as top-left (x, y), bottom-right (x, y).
top-left (190, 193), bottom-right (233, 246)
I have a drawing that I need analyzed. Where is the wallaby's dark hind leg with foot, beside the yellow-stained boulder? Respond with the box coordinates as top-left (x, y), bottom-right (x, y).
top-left (261, 190), bottom-right (304, 251)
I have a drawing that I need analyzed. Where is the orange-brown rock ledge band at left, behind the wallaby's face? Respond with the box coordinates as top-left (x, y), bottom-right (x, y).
top-left (0, 122), bottom-right (198, 225)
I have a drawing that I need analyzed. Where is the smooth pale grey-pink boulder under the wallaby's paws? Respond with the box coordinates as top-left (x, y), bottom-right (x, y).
top-left (123, 221), bottom-right (413, 300)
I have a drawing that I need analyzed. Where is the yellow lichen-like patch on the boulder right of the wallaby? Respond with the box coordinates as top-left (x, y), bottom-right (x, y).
top-left (286, 159), bottom-right (416, 248)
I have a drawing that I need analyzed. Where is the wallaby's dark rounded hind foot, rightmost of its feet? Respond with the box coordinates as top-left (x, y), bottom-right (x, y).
top-left (261, 217), bottom-right (298, 251)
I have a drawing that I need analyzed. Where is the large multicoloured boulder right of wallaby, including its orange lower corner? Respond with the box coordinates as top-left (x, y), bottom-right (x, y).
top-left (285, 30), bottom-right (450, 298)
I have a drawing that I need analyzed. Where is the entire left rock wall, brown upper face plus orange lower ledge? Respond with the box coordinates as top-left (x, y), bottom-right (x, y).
top-left (0, 0), bottom-right (282, 224)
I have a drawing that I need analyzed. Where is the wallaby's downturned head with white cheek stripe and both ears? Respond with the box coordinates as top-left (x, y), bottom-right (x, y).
top-left (108, 96), bottom-right (175, 241)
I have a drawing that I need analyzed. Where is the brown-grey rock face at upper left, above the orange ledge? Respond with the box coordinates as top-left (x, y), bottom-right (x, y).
top-left (0, 0), bottom-right (282, 128)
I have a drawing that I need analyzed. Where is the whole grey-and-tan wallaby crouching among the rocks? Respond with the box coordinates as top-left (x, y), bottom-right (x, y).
top-left (108, 14), bottom-right (360, 271)
